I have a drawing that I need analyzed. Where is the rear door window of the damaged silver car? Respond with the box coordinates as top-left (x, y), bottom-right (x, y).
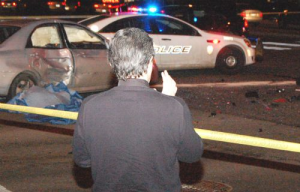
top-left (30, 25), bottom-right (62, 49)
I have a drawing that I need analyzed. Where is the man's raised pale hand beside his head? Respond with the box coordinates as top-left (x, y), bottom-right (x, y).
top-left (161, 70), bottom-right (177, 96)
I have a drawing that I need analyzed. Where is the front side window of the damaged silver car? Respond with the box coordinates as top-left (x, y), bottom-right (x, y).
top-left (64, 24), bottom-right (106, 49)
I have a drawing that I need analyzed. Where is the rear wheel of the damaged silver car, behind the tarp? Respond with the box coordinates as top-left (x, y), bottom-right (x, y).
top-left (6, 73), bottom-right (37, 100)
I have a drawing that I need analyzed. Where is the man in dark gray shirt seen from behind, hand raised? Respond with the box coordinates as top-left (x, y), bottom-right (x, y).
top-left (73, 28), bottom-right (203, 192)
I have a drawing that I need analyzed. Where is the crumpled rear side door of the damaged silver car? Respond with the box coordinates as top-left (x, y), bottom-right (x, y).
top-left (26, 24), bottom-right (74, 85)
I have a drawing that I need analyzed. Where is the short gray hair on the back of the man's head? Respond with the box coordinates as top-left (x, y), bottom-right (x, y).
top-left (108, 28), bottom-right (155, 80)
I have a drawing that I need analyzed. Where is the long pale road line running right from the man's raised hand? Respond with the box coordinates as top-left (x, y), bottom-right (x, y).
top-left (151, 81), bottom-right (296, 88)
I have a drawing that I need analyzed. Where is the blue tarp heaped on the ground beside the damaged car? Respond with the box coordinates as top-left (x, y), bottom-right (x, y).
top-left (8, 82), bottom-right (83, 125)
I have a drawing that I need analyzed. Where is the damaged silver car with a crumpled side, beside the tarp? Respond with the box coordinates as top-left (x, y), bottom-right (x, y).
top-left (0, 20), bottom-right (114, 99)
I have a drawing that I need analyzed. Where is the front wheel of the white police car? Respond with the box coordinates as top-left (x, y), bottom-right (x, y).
top-left (216, 47), bottom-right (245, 75)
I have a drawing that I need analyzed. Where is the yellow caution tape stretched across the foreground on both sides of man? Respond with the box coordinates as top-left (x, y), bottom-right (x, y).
top-left (0, 103), bottom-right (300, 153)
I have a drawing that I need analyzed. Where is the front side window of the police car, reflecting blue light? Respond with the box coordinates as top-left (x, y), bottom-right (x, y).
top-left (155, 17), bottom-right (199, 36)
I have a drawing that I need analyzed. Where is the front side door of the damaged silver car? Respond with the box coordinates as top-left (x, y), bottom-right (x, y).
top-left (64, 24), bottom-right (114, 92)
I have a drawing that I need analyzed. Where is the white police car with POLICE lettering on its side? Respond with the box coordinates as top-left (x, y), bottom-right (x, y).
top-left (79, 13), bottom-right (255, 74)
